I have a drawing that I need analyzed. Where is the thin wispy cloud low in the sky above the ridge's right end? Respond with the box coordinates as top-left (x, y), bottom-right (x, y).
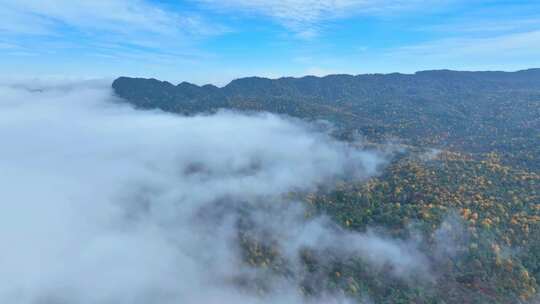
top-left (363, 30), bottom-right (540, 72)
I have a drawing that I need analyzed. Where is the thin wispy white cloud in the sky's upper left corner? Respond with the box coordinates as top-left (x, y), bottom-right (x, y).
top-left (0, 0), bottom-right (227, 57)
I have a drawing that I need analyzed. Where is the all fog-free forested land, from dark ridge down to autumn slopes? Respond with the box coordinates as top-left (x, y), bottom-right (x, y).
top-left (113, 69), bottom-right (540, 303)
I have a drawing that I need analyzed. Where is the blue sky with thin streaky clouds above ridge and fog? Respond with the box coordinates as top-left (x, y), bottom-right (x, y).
top-left (0, 0), bottom-right (540, 85)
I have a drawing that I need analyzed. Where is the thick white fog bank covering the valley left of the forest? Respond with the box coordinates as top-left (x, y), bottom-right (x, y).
top-left (0, 81), bottom-right (438, 304)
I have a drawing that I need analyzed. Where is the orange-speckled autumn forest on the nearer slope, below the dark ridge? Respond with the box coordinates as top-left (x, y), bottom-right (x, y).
top-left (308, 152), bottom-right (540, 303)
